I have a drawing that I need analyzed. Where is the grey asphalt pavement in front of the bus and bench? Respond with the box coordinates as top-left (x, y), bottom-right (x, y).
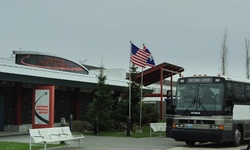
top-left (0, 135), bottom-right (247, 150)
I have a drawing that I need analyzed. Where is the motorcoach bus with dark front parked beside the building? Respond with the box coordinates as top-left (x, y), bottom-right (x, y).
top-left (166, 76), bottom-right (250, 146)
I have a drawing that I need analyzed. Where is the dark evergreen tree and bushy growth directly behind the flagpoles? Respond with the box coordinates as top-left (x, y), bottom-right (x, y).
top-left (113, 65), bottom-right (159, 130)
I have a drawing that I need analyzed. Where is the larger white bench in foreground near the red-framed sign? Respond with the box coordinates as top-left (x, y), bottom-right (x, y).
top-left (29, 127), bottom-right (84, 150)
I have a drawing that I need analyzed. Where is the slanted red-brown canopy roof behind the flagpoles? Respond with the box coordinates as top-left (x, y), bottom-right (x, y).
top-left (135, 62), bottom-right (184, 86)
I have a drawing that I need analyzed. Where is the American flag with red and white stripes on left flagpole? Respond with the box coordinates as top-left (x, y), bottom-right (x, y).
top-left (130, 43), bottom-right (151, 68)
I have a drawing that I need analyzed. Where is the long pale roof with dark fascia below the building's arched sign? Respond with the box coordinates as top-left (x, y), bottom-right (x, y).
top-left (0, 58), bottom-right (128, 90)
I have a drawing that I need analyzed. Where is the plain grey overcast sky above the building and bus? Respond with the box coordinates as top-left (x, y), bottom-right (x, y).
top-left (0, 0), bottom-right (250, 78)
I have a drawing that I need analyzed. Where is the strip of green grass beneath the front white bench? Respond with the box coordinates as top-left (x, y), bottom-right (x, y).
top-left (0, 142), bottom-right (62, 150)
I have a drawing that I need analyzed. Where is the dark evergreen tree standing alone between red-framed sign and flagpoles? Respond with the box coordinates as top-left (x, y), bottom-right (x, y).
top-left (86, 66), bottom-right (113, 131)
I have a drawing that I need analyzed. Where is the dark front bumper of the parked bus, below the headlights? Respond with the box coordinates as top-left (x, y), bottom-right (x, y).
top-left (172, 129), bottom-right (233, 142)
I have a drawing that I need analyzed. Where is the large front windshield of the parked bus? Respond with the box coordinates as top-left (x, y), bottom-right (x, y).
top-left (175, 83), bottom-right (224, 115)
